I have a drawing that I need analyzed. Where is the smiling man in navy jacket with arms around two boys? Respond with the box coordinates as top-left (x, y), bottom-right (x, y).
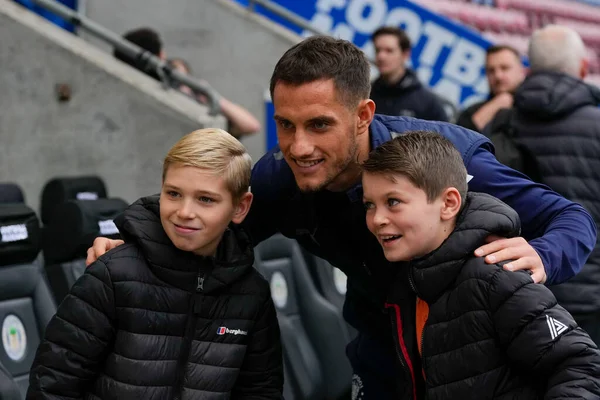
top-left (87, 36), bottom-right (596, 400)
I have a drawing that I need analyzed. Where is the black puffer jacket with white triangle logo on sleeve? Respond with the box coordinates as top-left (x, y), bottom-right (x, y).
top-left (386, 194), bottom-right (600, 400)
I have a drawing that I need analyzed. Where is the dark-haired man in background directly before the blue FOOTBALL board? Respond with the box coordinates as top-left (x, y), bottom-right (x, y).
top-left (371, 27), bottom-right (449, 121)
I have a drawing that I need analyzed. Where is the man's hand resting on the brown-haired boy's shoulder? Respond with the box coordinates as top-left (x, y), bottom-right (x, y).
top-left (475, 235), bottom-right (546, 283)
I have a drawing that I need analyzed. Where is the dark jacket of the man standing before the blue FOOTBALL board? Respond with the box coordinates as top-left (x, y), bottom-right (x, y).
top-left (371, 69), bottom-right (450, 121)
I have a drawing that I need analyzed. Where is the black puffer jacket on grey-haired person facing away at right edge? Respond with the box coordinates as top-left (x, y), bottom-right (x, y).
top-left (513, 72), bottom-right (600, 315)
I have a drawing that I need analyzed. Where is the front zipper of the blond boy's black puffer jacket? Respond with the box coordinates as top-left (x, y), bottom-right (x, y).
top-left (173, 272), bottom-right (205, 400)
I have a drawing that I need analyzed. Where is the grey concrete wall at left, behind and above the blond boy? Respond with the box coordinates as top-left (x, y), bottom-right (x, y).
top-left (0, 1), bottom-right (225, 209)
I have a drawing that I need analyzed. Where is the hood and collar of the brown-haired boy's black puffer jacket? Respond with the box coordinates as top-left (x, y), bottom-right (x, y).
top-left (410, 193), bottom-right (521, 303)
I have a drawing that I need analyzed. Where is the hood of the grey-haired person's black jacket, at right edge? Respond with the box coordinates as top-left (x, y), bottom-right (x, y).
top-left (514, 72), bottom-right (600, 120)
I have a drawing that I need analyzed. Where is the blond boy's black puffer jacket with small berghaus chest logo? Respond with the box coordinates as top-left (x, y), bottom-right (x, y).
top-left (27, 196), bottom-right (283, 400)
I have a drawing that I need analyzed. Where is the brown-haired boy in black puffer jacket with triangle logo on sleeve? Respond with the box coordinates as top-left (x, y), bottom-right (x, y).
top-left (358, 131), bottom-right (600, 400)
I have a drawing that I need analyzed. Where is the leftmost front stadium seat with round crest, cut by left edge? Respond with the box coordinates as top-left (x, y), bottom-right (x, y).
top-left (0, 204), bottom-right (56, 396)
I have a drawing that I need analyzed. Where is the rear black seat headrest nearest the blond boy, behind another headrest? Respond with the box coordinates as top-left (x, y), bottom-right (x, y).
top-left (40, 176), bottom-right (107, 224)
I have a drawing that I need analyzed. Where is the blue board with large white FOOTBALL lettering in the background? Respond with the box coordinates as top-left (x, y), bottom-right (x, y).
top-left (236, 0), bottom-right (490, 148)
